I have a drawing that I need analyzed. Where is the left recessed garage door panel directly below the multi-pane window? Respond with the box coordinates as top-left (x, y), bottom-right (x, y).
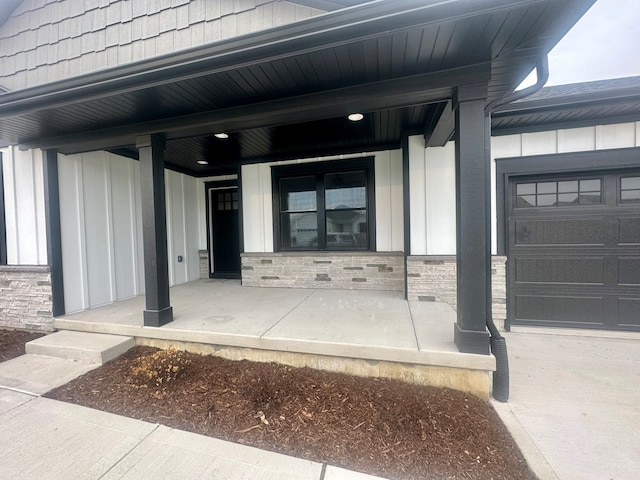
top-left (515, 218), bottom-right (605, 246)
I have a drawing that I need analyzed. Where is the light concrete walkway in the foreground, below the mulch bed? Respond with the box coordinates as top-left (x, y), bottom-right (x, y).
top-left (0, 388), bottom-right (384, 480)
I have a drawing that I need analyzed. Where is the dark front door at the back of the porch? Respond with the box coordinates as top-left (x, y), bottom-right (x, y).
top-left (208, 188), bottom-right (240, 278)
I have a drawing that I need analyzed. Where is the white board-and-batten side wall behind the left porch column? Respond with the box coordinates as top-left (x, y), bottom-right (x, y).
top-left (58, 152), bottom-right (204, 313)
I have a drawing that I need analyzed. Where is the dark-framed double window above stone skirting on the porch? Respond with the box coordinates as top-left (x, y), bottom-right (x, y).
top-left (272, 158), bottom-right (375, 251)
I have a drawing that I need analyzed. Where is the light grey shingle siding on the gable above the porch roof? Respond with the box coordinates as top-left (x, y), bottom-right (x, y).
top-left (0, 0), bottom-right (323, 90)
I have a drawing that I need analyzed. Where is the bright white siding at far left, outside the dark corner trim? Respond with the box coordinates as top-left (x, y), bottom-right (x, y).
top-left (1, 147), bottom-right (47, 265)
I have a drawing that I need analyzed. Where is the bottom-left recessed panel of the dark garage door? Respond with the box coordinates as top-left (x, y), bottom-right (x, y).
top-left (515, 295), bottom-right (604, 325)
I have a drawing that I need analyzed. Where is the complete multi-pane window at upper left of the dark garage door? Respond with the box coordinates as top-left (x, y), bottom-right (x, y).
top-left (516, 178), bottom-right (602, 208)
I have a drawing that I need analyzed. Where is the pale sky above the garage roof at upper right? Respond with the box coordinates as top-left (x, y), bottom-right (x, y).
top-left (525, 0), bottom-right (640, 86)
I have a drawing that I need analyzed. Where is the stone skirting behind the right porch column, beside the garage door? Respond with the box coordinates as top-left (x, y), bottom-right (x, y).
top-left (407, 255), bottom-right (507, 329)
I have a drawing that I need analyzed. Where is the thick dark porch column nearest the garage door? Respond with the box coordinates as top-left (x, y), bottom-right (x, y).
top-left (454, 84), bottom-right (491, 354)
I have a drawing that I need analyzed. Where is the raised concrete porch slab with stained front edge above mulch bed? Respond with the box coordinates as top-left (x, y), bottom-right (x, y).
top-left (54, 279), bottom-right (495, 398)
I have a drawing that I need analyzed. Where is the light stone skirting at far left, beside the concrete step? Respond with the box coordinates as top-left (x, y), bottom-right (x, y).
top-left (0, 265), bottom-right (53, 331)
